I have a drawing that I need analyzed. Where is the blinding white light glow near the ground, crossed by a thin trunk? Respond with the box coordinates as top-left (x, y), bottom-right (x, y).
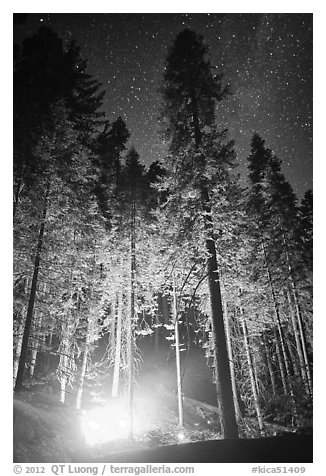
top-left (81, 400), bottom-right (152, 446)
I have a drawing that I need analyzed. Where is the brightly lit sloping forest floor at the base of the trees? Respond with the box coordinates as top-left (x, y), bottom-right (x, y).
top-left (13, 387), bottom-right (314, 463)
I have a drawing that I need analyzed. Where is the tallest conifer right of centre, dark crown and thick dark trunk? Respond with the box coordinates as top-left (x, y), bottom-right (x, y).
top-left (162, 29), bottom-right (238, 438)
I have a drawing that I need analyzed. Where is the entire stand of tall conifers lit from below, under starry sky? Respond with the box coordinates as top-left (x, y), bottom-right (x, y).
top-left (13, 24), bottom-right (313, 444)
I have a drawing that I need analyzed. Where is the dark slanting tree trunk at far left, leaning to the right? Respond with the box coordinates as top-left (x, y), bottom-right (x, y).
top-left (15, 183), bottom-right (50, 392)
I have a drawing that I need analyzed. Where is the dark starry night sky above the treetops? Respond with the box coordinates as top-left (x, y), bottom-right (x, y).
top-left (14, 13), bottom-right (312, 199)
